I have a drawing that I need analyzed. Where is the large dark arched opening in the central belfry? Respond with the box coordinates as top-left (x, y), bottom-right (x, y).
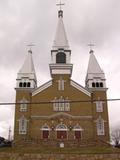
top-left (56, 52), bottom-right (66, 63)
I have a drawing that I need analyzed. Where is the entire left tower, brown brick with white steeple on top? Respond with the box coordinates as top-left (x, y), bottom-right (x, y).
top-left (14, 50), bottom-right (37, 141)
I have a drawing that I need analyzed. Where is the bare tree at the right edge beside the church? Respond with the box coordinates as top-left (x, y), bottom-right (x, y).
top-left (111, 129), bottom-right (120, 147)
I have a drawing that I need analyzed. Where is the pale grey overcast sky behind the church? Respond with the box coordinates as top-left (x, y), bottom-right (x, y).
top-left (0, 0), bottom-right (120, 137)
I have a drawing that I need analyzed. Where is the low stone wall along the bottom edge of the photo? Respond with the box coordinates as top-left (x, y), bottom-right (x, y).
top-left (0, 153), bottom-right (120, 160)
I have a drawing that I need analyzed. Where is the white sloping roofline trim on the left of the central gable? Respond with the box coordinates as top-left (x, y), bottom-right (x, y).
top-left (32, 80), bottom-right (52, 96)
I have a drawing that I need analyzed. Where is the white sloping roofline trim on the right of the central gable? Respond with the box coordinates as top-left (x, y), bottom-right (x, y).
top-left (70, 80), bottom-right (91, 97)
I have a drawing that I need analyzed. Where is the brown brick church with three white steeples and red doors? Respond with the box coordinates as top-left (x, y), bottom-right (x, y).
top-left (14, 9), bottom-right (109, 147)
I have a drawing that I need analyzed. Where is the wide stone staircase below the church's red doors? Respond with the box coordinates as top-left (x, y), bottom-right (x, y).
top-left (13, 138), bottom-right (110, 148)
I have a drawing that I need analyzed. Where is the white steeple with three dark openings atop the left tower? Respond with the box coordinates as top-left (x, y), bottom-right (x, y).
top-left (17, 50), bottom-right (37, 88)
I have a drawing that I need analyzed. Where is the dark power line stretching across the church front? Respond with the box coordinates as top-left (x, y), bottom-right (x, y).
top-left (0, 98), bottom-right (120, 105)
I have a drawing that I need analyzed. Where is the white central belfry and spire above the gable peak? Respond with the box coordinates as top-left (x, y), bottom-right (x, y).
top-left (49, 9), bottom-right (73, 77)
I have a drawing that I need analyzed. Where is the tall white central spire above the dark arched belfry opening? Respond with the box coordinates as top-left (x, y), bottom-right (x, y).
top-left (53, 10), bottom-right (69, 49)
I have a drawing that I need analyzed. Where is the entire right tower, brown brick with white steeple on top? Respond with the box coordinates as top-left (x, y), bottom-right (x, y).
top-left (85, 49), bottom-right (109, 141)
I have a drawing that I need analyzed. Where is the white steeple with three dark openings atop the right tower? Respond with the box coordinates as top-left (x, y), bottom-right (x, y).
top-left (86, 50), bottom-right (106, 89)
